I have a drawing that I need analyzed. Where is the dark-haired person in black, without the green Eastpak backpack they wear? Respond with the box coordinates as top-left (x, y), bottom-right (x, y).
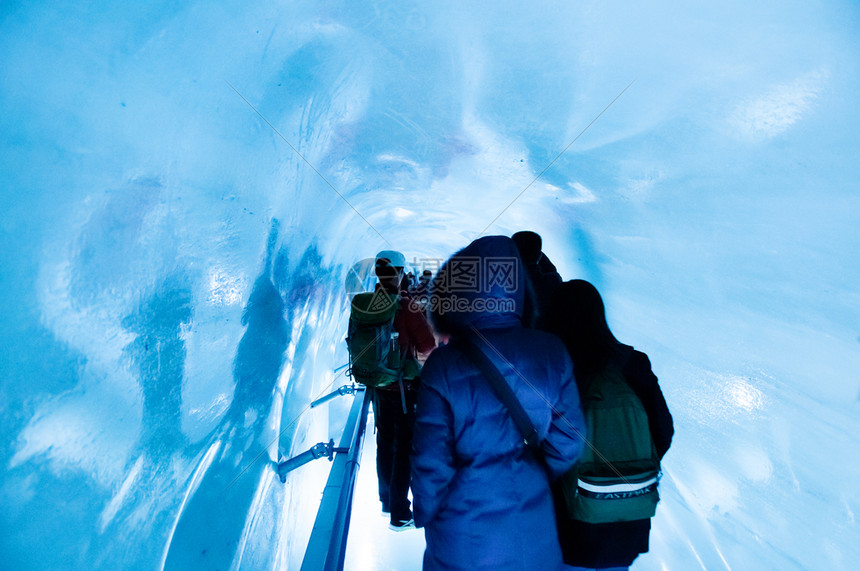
top-left (548, 280), bottom-right (674, 570)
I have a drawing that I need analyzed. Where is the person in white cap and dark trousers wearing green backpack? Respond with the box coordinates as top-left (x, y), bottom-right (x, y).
top-left (358, 250), bottom-right (436, 531)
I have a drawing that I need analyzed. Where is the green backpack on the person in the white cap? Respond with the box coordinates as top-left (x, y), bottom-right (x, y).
top-left (346, 291), bottom-right (404, 387)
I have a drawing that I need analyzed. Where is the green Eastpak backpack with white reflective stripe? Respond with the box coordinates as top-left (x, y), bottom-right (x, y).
top-left (561, 349), bottom-right (660, 523)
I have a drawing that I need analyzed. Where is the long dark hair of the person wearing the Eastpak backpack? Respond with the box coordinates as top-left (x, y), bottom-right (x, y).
top-left (547, 280), bottom-right (622, 380)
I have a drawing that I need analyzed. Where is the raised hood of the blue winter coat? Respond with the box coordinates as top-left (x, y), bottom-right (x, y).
top-left (430, 236), bottom-right (526, 334)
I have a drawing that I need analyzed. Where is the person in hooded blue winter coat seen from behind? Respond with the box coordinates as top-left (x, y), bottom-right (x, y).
top-left (412, 236), bottom-right (585, 571)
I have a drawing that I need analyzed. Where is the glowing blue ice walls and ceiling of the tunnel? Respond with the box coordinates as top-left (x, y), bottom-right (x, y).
top-left (0, 0), bottom-right (860, 569)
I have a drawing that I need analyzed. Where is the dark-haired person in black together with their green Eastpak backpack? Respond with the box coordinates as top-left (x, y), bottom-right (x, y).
top-left (548, 280), bottom-right (674, 569)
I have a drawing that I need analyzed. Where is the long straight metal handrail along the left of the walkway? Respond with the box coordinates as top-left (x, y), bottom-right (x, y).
top-left (301, 386), bottom-right (370, 571)
